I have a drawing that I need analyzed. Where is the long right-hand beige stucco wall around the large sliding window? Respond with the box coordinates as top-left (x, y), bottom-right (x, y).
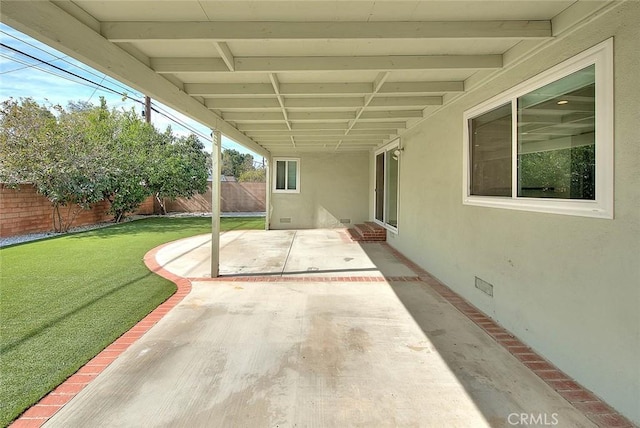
top-left (380, 1), bottom-right (640, 423)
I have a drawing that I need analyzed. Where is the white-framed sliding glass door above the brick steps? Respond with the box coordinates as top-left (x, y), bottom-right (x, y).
top-left (374, 139), bottom-right (402, 232)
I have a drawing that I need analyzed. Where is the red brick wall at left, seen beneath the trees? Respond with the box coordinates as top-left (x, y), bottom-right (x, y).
top-left (0, 184), bottom-right (153, 238)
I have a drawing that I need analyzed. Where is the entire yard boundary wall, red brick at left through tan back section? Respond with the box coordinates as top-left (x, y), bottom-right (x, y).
top-left (0, 182), bottom-right (266, 238)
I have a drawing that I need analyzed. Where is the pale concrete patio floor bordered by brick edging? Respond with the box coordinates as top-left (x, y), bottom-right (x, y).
top-left (45, 230), bottom-right (595, 427)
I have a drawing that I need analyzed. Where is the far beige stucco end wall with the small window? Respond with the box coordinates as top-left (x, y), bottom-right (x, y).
top-left (270, 152), bottom-right (369, 229)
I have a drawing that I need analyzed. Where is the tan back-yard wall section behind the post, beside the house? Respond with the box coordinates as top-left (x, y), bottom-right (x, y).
top-left (167, 181), bottom-right (267, 212)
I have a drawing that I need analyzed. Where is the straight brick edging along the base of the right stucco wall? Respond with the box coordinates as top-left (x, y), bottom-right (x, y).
top-left (380, 242), bottom-right (636, 428)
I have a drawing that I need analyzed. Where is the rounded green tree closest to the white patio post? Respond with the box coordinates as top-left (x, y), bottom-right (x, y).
top-left (147, 132), bottom-right (209, 214)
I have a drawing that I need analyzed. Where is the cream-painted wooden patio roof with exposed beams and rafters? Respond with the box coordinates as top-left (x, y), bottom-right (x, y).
top-left (2, 0), bottom-right (610, 155)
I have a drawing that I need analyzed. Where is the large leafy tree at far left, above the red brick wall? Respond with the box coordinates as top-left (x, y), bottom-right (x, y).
top-left (0, 99), bottom-right (107, 232)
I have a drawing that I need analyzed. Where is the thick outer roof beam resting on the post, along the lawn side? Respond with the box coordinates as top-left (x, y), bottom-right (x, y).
top-left (0, 1), bottom-right (269, 156)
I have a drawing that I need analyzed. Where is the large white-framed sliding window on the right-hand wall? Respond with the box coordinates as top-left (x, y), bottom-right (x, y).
top-left (463, 39), bottom-right (613, 218)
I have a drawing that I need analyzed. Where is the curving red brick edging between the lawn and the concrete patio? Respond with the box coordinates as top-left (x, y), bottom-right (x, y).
top-left (10, 241), bottom-right (191, 428)
